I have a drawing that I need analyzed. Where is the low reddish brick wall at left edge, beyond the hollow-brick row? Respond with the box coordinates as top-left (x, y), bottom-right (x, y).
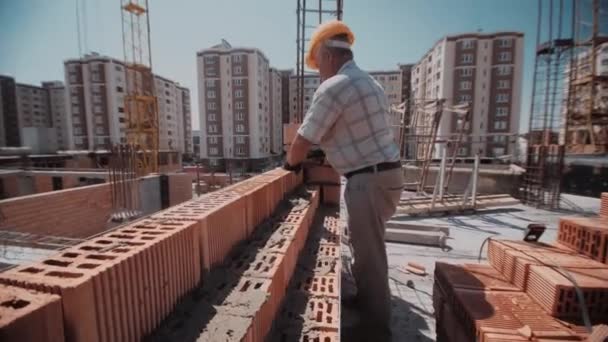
top-left (0, 184), bottom-right (112, 238)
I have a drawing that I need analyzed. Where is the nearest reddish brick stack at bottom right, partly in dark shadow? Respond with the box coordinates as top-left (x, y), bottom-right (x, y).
top-left (433, 263), bottom-right (585, 342)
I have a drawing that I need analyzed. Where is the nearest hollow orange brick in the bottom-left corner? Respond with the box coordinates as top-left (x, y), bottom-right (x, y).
top-left (0, 285), bottom-right (65, 342)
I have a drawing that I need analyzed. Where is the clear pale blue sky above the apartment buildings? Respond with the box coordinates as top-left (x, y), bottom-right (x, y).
top-left (0, 0), bottom-right (548, 128)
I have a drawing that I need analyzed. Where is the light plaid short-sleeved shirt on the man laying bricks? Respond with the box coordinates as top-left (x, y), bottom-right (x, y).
top-left (298, 61), bottom-right (399, 174)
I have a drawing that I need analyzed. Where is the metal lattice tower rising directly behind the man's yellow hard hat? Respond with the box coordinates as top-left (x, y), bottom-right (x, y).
top-left (292, 0), bottom-right (344, 123)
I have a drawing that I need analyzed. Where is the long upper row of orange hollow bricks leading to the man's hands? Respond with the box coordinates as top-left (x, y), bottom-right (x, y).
top-left (0, 170), bottom-right (304, 341)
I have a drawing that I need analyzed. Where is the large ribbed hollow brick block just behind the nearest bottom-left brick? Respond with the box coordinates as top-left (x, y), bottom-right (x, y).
top-left (0, 220), bottom-right (200, 341)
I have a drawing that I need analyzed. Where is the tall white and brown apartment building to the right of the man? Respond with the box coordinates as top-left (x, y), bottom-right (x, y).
top-left (411, 32), bottom-right (523, 157)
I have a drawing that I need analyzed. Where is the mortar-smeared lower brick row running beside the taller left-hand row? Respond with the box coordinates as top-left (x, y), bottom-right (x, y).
top-left (150, 190), bottom-right (319, 341)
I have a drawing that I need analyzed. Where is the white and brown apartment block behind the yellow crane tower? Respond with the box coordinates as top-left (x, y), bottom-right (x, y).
top-left (64, 53), bottom-right (189, 153)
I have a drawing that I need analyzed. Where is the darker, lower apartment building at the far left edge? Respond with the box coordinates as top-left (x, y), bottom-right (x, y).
top-left (0, 75), bottom-right (66, 153)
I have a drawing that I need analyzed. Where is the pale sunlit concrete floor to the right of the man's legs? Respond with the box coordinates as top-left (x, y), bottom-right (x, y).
top-left (341, 193), bottom-right (600, 341)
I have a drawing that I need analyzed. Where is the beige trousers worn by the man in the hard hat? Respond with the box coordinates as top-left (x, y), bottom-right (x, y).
top-left (344, 168), bottom-right (403, 341)
